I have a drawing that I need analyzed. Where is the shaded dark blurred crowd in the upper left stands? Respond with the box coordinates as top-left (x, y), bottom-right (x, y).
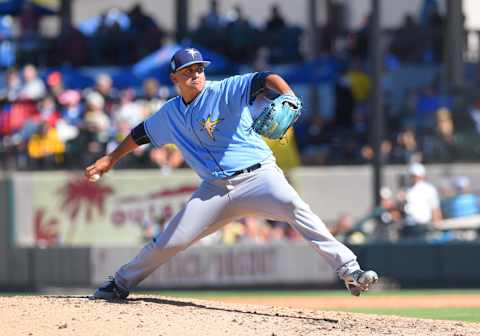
top-left (5, 1), bottom-right (167, 66)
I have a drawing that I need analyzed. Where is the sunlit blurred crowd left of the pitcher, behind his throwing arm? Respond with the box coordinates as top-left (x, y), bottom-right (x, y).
top-left (0, 64), bottom-right (183, 172)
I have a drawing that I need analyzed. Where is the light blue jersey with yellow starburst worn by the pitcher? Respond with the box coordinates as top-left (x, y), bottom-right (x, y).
top-left (145, 73), bottom-right (272, 180)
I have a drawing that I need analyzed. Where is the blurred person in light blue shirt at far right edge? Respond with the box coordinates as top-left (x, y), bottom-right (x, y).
top-left (442, 176), bottom-right (480, 218)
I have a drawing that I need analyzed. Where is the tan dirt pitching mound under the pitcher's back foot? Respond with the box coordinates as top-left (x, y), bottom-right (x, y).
top-left (0, 295), bottom-right (480, 336)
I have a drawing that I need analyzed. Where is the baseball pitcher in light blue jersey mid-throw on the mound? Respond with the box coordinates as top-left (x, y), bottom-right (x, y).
top-left (85, 48), bottom-right (378, 300)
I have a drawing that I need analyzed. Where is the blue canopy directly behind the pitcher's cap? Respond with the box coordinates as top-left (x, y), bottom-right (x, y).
top-left (132, 44), bottom-right (238, 84)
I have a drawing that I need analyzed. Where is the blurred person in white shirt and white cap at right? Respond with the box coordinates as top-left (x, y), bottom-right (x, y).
top-left (402, 163), bottom-right (442, 238)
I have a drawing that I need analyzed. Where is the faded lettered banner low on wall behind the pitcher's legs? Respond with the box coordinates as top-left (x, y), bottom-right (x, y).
top-left (90, 242), bottom-right (337, 288)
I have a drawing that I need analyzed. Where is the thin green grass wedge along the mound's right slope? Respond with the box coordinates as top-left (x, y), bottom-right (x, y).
top-left (331, 308), bottom-right (480, 322)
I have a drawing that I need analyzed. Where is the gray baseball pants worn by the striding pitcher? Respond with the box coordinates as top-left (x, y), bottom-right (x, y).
top-left (115, 162), bottom-right (360, 290)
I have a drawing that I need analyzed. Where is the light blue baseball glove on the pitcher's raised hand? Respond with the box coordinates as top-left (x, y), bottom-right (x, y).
top-left (252, 94), bottom-right (302, 139)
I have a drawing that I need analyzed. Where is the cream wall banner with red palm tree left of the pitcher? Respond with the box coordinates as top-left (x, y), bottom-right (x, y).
top-left (12, 170), bottom-right (199, 247)
